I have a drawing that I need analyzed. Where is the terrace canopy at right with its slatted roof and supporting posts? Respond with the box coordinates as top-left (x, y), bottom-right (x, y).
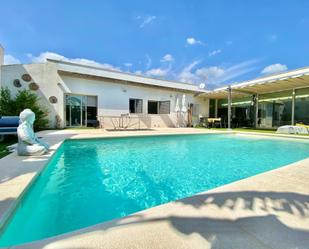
top-left (203, 67), bottom-right (309, 129)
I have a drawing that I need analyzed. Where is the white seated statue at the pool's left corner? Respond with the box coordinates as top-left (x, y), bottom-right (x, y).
top-left (17, 109), bottom-right (49, 156)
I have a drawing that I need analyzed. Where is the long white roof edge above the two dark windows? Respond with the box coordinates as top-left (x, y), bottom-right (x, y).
top-left (47, 59), bottom-right (208, 93)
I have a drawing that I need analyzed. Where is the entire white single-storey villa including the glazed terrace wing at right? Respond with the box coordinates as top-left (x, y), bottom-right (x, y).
top-left (0, 45), bottom-right (309, 129)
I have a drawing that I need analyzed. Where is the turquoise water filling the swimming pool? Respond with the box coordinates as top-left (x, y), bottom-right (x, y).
top-left (0, 135), bottom-right (309, 246)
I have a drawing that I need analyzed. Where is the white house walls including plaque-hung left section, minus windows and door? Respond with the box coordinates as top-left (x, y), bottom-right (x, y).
top-left (1, 62), bottom-right (208, 128)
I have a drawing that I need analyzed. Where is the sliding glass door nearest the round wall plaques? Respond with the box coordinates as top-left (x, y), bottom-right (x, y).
top-left (65, 94), bottom-right (97, 127)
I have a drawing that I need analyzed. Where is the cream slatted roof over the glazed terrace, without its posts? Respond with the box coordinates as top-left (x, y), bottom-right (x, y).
top-left (203, 67), bottom-right (309, 99)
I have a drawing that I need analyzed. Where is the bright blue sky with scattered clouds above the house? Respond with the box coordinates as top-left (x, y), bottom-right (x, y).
top-left (0, 0), bottom-right (309, 89)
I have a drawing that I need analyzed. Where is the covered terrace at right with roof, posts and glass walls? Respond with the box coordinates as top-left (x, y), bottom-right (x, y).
top-left (203, 67), bottom-right (309, 129)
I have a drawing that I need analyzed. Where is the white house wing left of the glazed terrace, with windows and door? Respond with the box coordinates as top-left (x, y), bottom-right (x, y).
top-left (0, 59), bottom-right (209, 129)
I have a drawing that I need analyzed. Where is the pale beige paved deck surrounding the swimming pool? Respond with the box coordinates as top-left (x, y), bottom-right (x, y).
top-left (0, 128), bottom-right (309, 249)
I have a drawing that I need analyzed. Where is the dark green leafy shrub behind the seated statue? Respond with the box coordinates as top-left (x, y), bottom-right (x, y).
top-left (0, 88), bottom-right (48, 130)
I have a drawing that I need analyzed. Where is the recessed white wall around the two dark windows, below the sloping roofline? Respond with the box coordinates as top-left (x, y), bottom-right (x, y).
top-left (61, 75), bottom-right (208, 128)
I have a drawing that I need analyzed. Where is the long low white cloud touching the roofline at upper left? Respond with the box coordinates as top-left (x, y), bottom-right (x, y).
top-left (27, 51), bottom-right (121, 71)
